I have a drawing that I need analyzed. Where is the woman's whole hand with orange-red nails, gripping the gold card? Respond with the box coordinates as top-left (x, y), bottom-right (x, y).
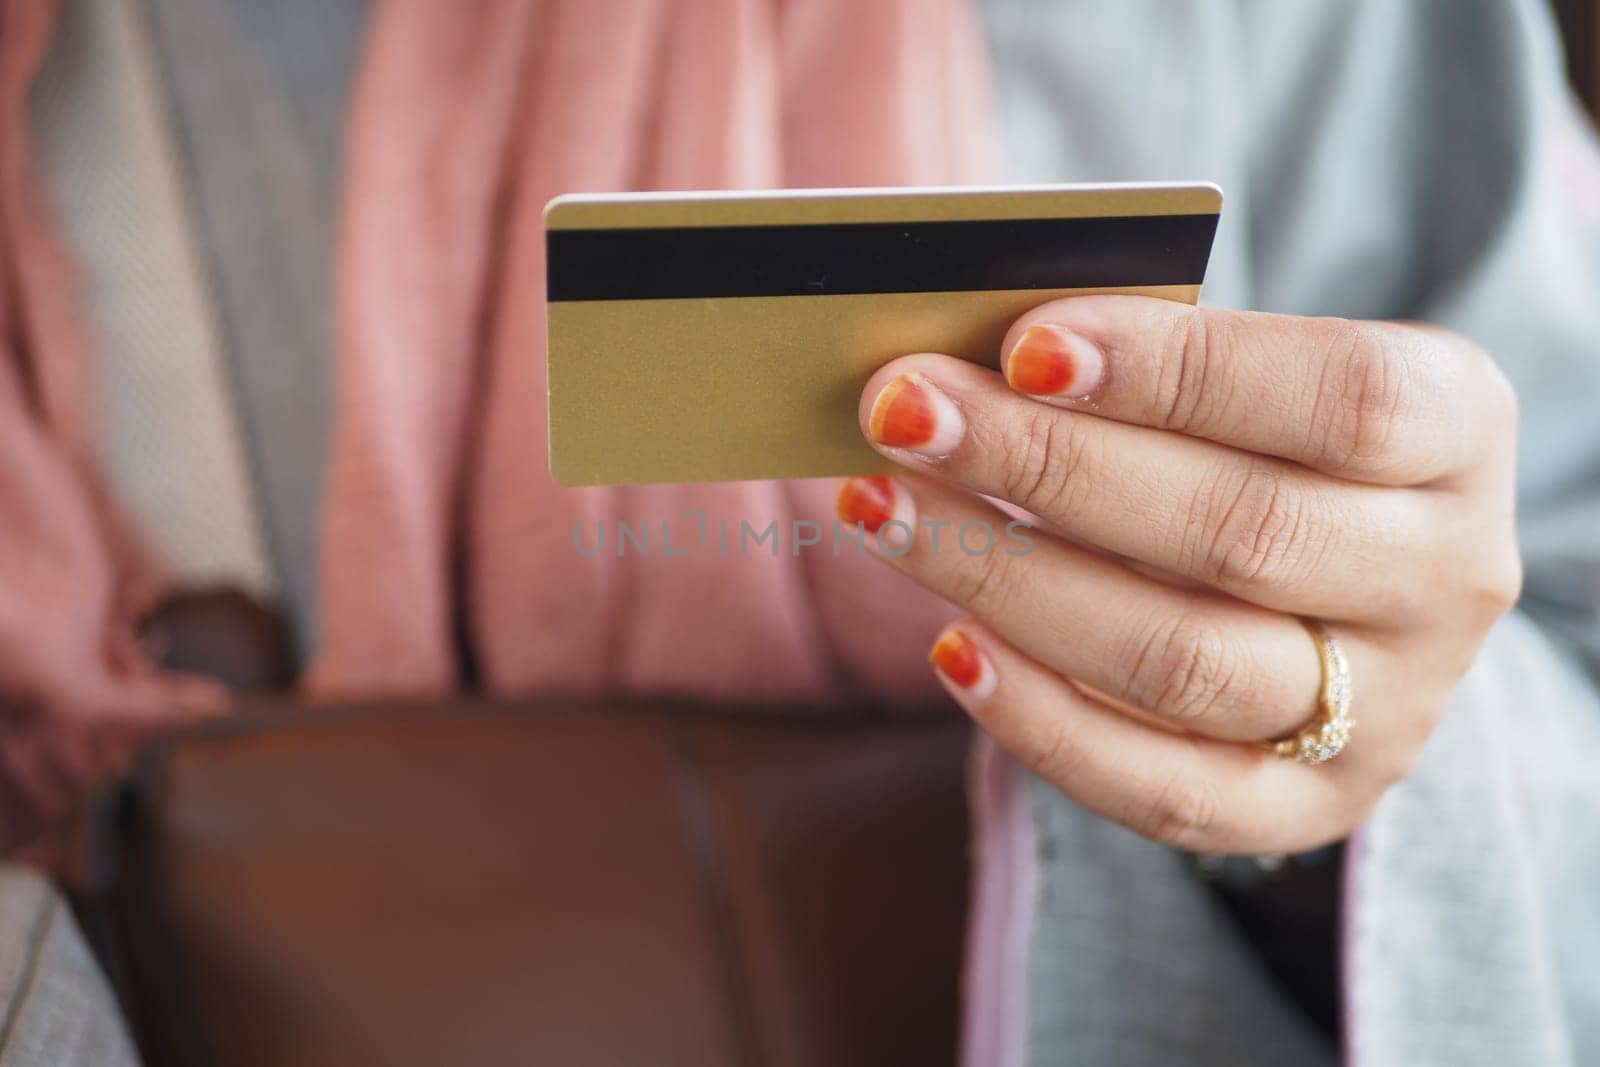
top-left (842, 296), bottom-right (1518, 851)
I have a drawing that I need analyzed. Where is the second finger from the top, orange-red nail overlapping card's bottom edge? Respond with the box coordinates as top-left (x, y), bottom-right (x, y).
top-left (861, 355), bottom-right (1429, 621)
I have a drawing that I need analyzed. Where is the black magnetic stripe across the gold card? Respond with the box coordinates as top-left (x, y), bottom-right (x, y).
top-left (547, 214), bottom-right (1218, 301)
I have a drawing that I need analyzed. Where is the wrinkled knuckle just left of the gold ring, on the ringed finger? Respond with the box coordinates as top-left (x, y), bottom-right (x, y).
top-left (1126, 613), bottom-right (1246, 723)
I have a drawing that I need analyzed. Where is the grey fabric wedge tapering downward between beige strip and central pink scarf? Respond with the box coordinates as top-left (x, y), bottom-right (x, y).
top-left (137, 0), bottom-right (365, 653)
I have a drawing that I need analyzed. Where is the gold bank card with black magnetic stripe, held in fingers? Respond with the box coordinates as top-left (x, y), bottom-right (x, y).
top-left (544, 184), bottom-right (1222, 485)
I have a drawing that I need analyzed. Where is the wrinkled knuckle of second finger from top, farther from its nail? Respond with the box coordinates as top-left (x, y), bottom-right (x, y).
top-left (1182, 464), bottom-right (1328, 589)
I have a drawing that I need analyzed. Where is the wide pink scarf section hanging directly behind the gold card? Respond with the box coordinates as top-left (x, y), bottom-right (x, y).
top-left (312, 0), bottom-right (997, 709)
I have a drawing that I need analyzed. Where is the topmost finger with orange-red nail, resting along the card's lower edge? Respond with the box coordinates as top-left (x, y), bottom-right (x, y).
top-left (1002, 296), bottom-right (1510, 485)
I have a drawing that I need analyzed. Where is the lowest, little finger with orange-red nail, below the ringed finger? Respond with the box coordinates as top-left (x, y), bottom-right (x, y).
top-left (930, 621), bottom-right (1349, 853)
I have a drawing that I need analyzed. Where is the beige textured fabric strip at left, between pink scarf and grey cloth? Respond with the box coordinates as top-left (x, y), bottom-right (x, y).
top-left (29, 0), bottom-right (272, 595)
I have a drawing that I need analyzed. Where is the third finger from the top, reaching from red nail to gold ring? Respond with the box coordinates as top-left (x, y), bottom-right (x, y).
top-left (838, 478), bottom-right (1320, 741)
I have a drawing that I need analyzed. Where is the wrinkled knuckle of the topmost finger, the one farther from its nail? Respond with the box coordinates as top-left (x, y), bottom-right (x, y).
top-left (1307, 320), bottom-right (1421, 474)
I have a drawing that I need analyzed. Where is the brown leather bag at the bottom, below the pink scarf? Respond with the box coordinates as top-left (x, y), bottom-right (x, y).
top-left (88, 702), bottom-right (968, 1067)
